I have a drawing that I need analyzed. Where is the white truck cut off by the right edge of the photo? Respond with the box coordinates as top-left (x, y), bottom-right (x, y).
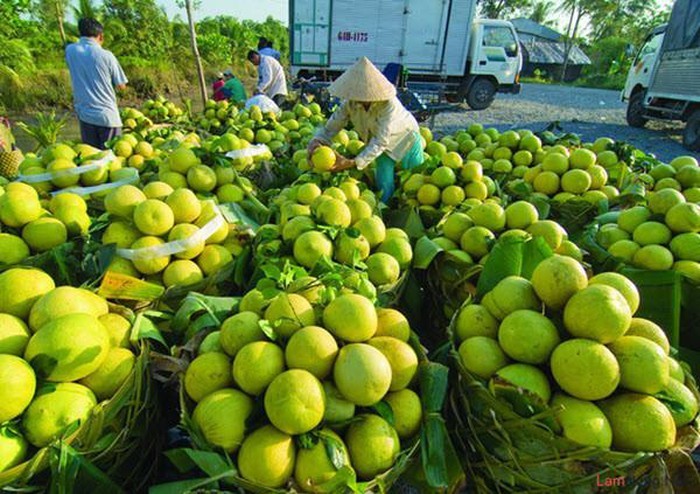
top-left (622, 0), bottom-right (700, 151)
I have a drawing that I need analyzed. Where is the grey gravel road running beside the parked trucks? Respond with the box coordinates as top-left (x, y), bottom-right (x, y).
top-left (435, 84), bottom-right (700, 161)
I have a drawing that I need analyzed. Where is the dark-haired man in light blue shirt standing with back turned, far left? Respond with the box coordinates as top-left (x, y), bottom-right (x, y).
top-left (66, 19), bottom-right (128, 149)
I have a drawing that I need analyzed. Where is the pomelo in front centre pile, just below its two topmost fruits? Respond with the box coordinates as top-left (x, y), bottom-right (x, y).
top-left (284, 326), bottom-right (338, 379)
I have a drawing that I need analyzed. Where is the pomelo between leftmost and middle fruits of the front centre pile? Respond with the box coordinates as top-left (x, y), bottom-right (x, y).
top-left (233, 341), bottom-right (284, 396)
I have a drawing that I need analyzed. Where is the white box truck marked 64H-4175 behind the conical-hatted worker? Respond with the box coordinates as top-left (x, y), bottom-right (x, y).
top-left (289, 0), bottom-right (522, 110)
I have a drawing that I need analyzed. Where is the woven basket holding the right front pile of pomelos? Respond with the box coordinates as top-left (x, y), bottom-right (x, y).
top-left (446, 288), bottom-right (700, 494)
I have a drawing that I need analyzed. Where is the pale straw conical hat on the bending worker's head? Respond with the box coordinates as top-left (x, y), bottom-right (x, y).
top-left (328, 57), bottom-right (396, 101)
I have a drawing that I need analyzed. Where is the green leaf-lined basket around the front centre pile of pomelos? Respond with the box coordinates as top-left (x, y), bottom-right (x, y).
top-left (151, 297), bottom-right (461, 494)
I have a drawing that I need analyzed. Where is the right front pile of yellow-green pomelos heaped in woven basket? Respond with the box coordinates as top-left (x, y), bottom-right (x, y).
top-left (454, 254), bottom-right (698, 452)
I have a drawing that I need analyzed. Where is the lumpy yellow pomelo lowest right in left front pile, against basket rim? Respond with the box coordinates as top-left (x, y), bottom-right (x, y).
top-left (22, 383), bottom-right (97, 448)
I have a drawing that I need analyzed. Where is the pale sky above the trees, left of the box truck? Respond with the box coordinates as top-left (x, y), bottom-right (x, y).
top-left (157, 0), bottom-right (289, 24)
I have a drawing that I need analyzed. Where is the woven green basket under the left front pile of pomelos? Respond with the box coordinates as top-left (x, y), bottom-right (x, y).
top-left (0, 304), bottom-right (161, 493)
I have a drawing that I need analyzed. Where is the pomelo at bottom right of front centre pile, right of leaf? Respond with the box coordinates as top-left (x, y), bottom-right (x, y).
top-left (345, 414), bottom-right (400, 480)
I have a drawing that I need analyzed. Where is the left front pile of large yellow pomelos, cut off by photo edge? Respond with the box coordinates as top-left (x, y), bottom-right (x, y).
top-left (0, 268), bottom-right (136, 471)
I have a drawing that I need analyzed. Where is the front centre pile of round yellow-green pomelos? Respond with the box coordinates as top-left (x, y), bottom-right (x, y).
top-left (183, 292), bottom-right (422, 492)
